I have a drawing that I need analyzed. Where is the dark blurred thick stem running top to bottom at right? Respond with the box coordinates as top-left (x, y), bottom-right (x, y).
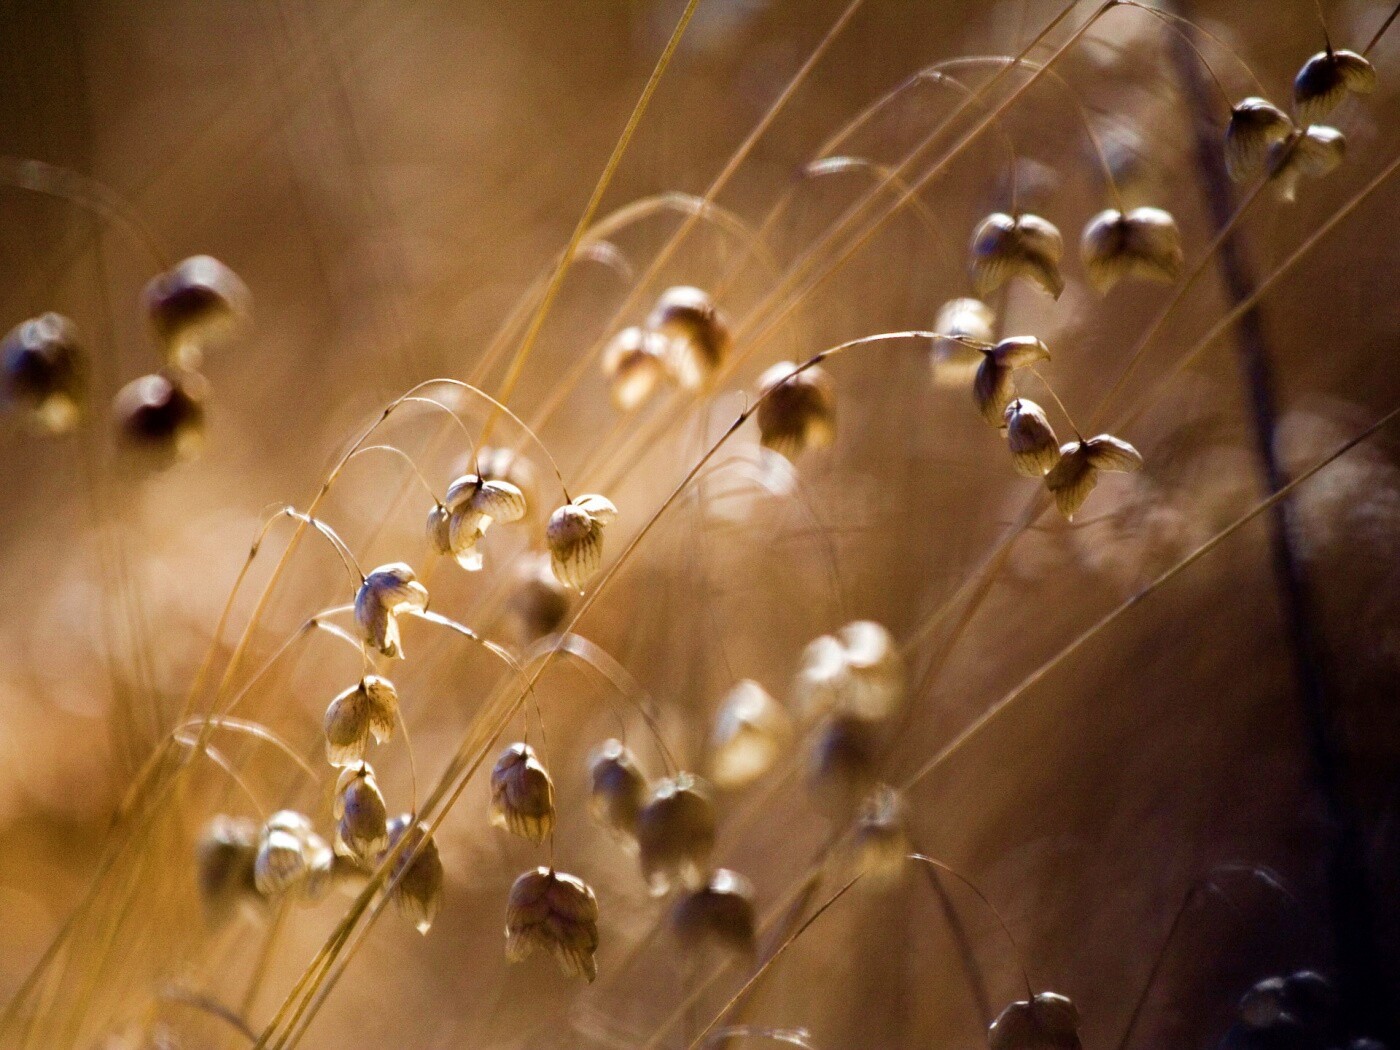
top-left (1173, 0), bottom-right (1396, 1042)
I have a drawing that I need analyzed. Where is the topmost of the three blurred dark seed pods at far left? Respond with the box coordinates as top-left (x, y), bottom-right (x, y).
top-left (141, 255), bottom-right (252, 368)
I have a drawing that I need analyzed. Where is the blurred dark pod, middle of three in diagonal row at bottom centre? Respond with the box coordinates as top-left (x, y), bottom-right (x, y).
top-left (637, 773), bottom-right (715, 897)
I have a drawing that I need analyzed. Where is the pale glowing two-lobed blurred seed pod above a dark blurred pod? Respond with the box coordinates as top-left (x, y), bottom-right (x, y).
top-left (792, 620), bottom-right (904, 721)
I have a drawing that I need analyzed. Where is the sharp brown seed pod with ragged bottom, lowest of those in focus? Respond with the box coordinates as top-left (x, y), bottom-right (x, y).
top-left (505, 868), bottom-right (598, 981)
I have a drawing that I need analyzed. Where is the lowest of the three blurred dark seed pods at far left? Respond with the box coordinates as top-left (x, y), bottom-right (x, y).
top-left (112, 370), bottom-right (209, 468)
